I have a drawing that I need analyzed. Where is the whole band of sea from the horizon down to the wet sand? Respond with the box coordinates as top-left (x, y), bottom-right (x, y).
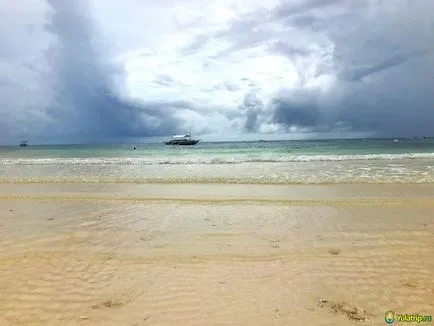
top-left (0, 139), bottom-right (434, 184)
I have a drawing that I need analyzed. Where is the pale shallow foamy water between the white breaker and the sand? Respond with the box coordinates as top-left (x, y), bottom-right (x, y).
top-left (0, 154), bottom-right (434, 185)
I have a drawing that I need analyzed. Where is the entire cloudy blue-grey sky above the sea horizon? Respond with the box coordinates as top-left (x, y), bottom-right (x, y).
top-left (0, 0), bottom-right (434, 144)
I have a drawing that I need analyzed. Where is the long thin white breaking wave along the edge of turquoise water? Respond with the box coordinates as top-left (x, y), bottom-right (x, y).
top-left (0, 153), bottom-right (434, 165)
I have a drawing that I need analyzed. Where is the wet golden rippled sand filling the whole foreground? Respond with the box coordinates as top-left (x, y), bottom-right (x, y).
top-left (0, 184), bottom-right (434, 325)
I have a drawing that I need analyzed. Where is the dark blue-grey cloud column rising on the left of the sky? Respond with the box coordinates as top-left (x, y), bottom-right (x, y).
top-left (43, 0), bottom-right (180, 140)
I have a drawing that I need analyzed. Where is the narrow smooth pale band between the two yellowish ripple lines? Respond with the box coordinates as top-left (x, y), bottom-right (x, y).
top-left (0, 182), bottom-right (434, 199)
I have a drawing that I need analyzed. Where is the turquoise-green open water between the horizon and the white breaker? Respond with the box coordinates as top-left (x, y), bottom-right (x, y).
top-left (0, 139), bottom-right (434, 163)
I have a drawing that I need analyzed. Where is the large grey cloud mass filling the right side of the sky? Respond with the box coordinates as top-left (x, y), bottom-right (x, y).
top-left (237, 0), bottom-right (434, 136)
